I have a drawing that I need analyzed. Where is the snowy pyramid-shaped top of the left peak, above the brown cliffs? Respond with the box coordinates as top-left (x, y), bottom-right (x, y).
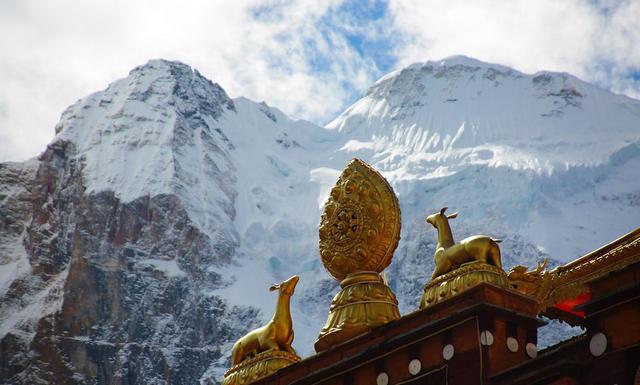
top-left (52, 60), bottom-right (236, 229)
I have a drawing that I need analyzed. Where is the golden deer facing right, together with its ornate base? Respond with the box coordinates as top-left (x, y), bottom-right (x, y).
top-left (223, 276), bottom-right (300, 385)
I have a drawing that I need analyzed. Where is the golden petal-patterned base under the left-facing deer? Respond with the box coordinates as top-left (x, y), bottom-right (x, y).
top-left (420, 261), bottom-right (511, 309)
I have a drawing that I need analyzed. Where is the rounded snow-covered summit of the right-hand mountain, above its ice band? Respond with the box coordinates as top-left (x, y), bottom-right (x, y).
top-left (327, 56), bottom-right (640, 172)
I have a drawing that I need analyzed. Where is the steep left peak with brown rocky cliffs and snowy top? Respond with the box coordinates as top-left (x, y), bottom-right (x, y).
top-left (0, 62), bottom-right (257, 384)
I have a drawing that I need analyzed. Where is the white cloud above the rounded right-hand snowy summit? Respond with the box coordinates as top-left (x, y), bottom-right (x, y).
top-left (390, 0), bottom-right (640, 96)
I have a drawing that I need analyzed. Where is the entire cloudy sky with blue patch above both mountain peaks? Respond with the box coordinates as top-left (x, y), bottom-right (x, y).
top-left (0, 0), bottom-right (640, 161)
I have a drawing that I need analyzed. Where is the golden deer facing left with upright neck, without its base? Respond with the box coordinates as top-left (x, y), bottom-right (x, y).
top-left (427, 207), bottom-right (502, 279)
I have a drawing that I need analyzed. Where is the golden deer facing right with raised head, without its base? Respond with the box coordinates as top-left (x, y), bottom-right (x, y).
top-left (231, 275), bottom-right (300, 365)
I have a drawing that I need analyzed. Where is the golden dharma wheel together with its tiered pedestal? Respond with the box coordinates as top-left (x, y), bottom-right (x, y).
top-left (315, 159), bottom-right (400, 352)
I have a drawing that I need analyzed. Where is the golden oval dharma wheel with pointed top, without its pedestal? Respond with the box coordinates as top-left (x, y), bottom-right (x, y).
top-left (320, 159), bottom-right (400, 280)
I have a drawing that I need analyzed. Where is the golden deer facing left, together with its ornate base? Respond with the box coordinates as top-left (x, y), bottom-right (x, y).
top-left (420, 207), bottom-right (510, 309)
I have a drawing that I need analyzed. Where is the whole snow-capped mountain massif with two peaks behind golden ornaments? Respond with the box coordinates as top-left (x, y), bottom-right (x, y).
top-left (0, 57), bottom-right (640, 384)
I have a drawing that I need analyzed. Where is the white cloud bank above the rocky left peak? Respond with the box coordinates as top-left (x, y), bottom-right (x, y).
top-left (0, 0), bottom-right (378, 161)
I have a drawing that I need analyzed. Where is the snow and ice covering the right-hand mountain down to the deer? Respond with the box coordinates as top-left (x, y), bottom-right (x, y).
top-left (328, 56), bottom-right (640, 260)
